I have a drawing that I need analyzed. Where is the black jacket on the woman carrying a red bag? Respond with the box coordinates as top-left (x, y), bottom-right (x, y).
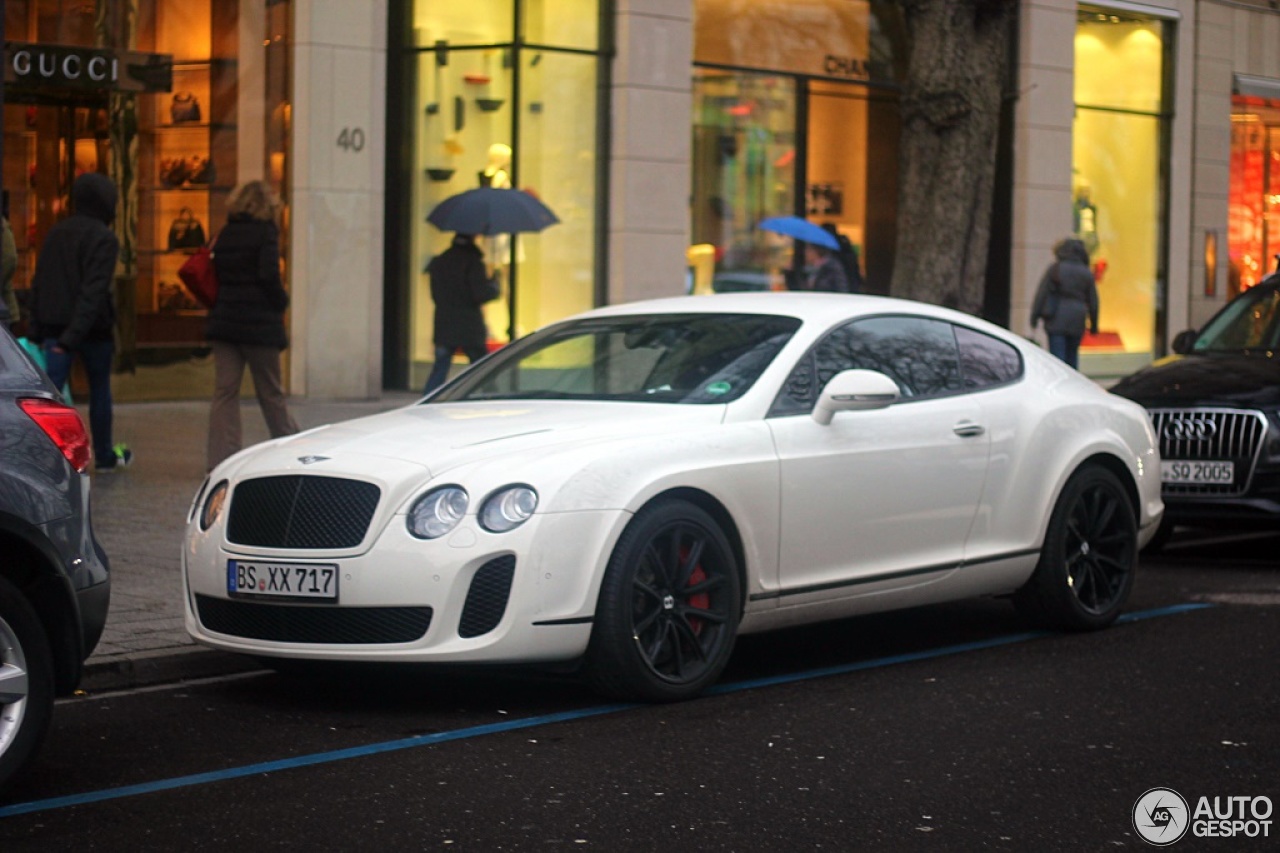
top-left (205, 214), bottom-right (289, 350)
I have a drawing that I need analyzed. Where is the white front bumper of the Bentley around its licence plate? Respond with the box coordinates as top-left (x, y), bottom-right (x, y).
top-left (183, 510), bottom-right (630, 663)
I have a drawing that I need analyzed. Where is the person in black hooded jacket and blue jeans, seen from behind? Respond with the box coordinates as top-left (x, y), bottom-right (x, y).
top-left (31, 172), bottom-right (133, 471)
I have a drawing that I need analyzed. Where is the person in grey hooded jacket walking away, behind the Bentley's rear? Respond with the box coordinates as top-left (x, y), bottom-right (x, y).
top-left (1032, 237), bottom-right (1098, 368)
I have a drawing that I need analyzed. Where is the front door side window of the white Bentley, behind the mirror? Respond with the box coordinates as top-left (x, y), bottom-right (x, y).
top-left (769, 316), bottom-right (965, 416)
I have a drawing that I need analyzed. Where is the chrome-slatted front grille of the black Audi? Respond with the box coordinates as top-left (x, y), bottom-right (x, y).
top-left (1151, 409), bottom-right (1267, 497)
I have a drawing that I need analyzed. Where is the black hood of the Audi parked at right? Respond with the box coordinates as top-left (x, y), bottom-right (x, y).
top-left (1111, 352), bottom-right (1280, 409)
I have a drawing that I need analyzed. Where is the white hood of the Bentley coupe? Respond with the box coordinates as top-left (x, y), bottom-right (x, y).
top-left (222, 401), bottom-right (724, 476)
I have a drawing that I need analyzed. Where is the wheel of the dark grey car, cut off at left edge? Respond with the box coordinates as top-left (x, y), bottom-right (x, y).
top-left (0, 578), bottom-right (54, 792)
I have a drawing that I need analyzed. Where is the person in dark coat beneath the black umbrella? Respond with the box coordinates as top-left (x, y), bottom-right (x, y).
top-left (422, 234), bottom-right (498, 394)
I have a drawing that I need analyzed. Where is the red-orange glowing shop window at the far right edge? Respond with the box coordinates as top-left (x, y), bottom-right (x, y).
top-left (1228, 95), bottom-right (1280, 292)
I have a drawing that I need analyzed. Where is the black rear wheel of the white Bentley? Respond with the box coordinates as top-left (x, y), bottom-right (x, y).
top-left (1014, 465), bottom-right (1138, 630)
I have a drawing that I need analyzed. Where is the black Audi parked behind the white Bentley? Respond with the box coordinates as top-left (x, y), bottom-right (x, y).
top-left (1112, 267), bottom-right (1280, 547)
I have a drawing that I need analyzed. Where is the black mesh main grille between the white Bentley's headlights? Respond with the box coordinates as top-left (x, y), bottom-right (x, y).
top-left (227, 475), bottom-right (381, 551)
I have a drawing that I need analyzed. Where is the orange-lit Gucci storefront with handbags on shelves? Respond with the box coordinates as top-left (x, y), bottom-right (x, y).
top-left (4, 0), bottom-right (289, 400)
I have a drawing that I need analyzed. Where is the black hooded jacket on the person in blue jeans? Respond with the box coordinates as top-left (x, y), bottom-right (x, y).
top-left (31, 172), bottom-right (120, 348)
